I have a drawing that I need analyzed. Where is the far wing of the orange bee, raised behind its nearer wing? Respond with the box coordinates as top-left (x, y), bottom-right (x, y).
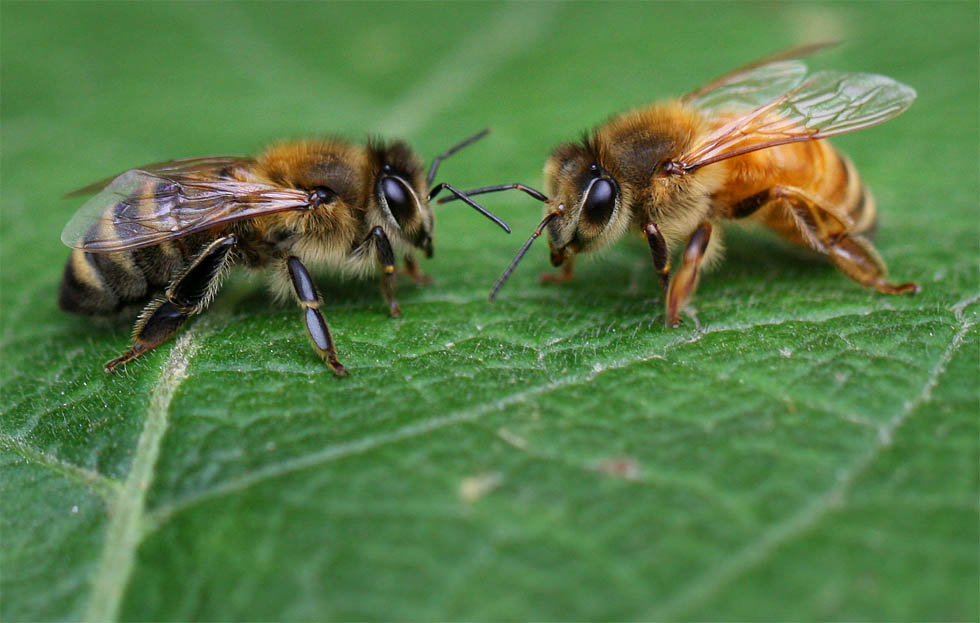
top-left (681, 41), bottom-right (839, 113)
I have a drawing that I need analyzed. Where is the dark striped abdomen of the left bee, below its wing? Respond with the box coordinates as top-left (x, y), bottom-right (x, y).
top-left (58, 235), bottom-right (212, 315)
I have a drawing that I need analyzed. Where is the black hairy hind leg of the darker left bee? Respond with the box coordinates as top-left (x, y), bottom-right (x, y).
top-left (105, 236), bottom-right (237, 372)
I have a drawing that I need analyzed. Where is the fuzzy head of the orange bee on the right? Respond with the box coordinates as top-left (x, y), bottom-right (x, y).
top-left (545, 139), bottom-right (629, 266)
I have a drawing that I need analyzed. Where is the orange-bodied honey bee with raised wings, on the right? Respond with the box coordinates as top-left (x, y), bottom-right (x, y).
top-left (443, 43), bottom-right (919, 326)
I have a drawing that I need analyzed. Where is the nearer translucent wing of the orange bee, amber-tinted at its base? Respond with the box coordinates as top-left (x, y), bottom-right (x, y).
top-left (670, 71), bottom-right (916, 172)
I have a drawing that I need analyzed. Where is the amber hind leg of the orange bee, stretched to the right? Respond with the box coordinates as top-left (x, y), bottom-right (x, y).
top-left (748, 186), bottom-right (920, 294)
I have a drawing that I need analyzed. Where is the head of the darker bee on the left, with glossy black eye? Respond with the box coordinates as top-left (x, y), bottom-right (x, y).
top-left (372, 141), bottom-right (435, 257)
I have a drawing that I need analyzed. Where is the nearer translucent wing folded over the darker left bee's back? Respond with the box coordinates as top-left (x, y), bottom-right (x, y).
top-left (61, 169), bottom-right (310, 253)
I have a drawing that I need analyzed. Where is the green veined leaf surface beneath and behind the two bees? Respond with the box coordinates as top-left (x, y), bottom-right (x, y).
top-left (0, 3), bottom-right (980, 621)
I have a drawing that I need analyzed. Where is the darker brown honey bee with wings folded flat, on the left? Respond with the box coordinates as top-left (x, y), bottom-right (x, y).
top-left (58, 130), bottom-right (510, 376)
